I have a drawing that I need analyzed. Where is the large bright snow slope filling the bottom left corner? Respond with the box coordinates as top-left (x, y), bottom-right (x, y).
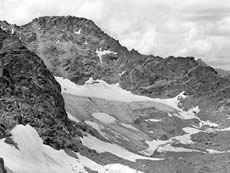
top-left (0, 125), bottom-right (144, 173)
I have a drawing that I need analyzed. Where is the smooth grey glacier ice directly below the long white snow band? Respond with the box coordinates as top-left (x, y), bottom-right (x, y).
top-left (62, 93), bottom-right (175, 123)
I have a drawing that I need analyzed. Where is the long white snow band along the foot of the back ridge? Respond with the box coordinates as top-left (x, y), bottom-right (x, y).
top-left (55, 77), bottom-right (199, 119)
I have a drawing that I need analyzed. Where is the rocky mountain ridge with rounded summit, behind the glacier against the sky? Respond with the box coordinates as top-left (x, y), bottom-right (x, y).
top-left (0, 16), bottom-right (230, 125)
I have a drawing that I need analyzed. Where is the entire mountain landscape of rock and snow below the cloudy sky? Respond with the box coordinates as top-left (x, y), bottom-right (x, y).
top-left (0, 16), bottom-right (230, 173)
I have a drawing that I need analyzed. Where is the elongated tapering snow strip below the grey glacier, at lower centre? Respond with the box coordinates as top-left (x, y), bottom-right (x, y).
top-left (81, 135), bottom-right (161, 162)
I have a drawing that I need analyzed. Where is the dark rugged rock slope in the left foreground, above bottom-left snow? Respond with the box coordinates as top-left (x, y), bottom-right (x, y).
top-left (0, 30), bottom-right (82, 149)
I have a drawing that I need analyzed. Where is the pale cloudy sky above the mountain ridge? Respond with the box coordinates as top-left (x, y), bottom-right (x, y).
top-left (0, 0), bottom-right (230, 70)
